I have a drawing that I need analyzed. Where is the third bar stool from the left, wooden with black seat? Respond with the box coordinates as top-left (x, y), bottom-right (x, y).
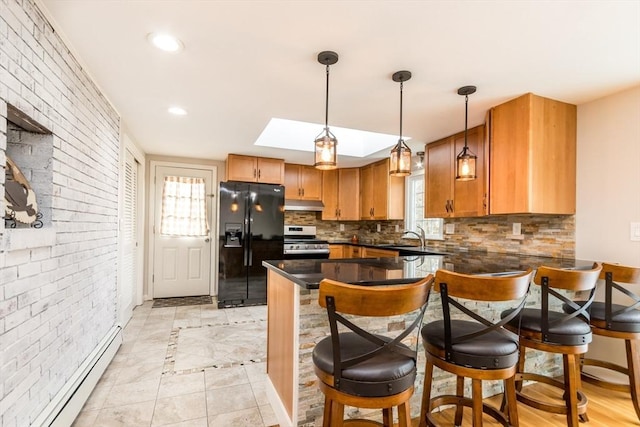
top-left (503, 263), bottom-right (602, 427)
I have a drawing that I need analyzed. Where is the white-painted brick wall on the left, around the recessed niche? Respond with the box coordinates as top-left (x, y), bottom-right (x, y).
top-left (0, 0), bottom-right (119, 427)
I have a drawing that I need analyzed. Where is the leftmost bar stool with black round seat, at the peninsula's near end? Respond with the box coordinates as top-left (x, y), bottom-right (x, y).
top-left (313, 275), bottom-right (433, 427)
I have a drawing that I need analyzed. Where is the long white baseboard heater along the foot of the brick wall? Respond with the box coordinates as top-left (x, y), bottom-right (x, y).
top-left (32, 325), bottom-right (122, 427)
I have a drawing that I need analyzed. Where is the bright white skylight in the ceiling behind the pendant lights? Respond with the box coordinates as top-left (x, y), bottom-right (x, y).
top-left (255, 118), bottom-right (411, 157)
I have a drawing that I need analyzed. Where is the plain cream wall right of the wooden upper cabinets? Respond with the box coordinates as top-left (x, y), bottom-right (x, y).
top-left (576, 86), bottom-right (640, 375)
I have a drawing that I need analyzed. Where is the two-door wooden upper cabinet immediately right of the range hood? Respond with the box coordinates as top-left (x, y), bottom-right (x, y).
top-left (322, 168), bottom-right (360, 221)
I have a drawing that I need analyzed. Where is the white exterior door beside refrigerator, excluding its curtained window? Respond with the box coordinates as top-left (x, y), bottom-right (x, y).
top-left (152, 165), bottom-right (215, 298)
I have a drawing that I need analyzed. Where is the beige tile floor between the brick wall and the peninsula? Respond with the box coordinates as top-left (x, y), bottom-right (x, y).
top-left (73, 301), bottom-right (277, 427)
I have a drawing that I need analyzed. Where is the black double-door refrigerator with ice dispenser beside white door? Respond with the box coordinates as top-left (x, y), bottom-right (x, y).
top-left (218, 182), bottom-right (284, 308)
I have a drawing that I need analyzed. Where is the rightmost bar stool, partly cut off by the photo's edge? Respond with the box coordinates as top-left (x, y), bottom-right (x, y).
top-left (578, 263), bottom-right (640, 420)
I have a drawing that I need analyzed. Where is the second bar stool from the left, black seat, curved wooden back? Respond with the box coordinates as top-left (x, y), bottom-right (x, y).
top-left (420, 269), bottom-right (532, 427)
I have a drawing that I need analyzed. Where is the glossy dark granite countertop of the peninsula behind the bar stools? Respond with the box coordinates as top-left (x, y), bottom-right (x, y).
top-left (262, 252), bottom-right (593, 289)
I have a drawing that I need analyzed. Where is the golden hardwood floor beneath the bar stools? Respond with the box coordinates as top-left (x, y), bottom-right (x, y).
top-left (412, 383), bottom-right (640, 427)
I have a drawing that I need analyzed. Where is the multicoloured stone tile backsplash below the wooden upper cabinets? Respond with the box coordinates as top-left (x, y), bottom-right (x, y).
top-left (285, 211), bottom-right (575, 258)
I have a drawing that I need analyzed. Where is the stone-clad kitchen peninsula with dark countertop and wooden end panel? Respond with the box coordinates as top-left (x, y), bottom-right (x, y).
top-left (263, 252), bottom-right (593, 426)
